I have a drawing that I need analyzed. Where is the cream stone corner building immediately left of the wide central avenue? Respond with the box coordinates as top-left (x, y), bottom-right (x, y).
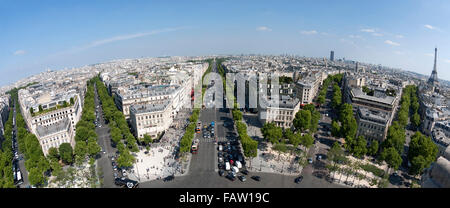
top-left (130, 100), bottom-right (173, 138)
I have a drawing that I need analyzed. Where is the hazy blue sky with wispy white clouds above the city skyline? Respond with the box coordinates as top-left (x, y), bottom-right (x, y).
top-left (0, 0), bottom-right (450, 85)
